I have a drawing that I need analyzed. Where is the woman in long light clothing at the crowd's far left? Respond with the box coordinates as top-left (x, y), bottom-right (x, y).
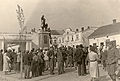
top-left (3, 50), bottom-right (10, 74)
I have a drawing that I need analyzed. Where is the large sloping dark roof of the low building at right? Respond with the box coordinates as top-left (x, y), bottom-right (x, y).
top-left (89, 22), bottom-right (120, 39)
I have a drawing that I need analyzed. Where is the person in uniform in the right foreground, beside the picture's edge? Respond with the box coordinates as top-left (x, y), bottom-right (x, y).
top-left (107, 41), bottom-right (120, 81)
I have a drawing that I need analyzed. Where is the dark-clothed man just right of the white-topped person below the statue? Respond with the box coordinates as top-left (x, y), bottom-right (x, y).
top-left (48, 47), bottom-right (54, 75)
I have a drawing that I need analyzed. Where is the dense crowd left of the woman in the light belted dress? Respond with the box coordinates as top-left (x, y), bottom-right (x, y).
top-left (0, 45), bottom-right (88, 79)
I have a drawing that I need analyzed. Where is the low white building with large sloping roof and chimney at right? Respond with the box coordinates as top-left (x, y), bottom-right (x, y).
top-left (89, 20), bottom-right (120, 46)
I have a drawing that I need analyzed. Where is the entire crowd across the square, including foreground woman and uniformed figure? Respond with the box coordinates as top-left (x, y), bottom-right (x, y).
top-left (0, 42), bottom-right (120, 81)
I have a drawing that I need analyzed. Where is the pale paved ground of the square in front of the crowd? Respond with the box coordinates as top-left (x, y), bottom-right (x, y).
top-left (0, 67), bottom-right (117, 81)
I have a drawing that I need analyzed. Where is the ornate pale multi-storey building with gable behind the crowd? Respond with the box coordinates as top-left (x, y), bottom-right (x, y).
top-left (57, 27), bottom-right (94, 46)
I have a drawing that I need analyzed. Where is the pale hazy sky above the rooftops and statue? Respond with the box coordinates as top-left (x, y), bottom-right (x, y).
top-left (0, 0), bottom-right (120, 33)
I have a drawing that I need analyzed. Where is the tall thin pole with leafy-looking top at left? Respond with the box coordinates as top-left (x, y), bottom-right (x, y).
top-left (16, 5), bottom-right (25, 79)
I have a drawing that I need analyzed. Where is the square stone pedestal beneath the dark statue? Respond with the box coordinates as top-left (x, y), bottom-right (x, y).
top-left (39, 31), bottom-right (50, 49)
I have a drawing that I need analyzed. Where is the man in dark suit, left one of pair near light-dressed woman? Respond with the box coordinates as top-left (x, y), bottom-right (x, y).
top-left (75, 45), bottom-right (83, 76)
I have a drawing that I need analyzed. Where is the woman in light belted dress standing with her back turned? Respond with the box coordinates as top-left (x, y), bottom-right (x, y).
top-left (89, 46), bottom-right (99, 81)
